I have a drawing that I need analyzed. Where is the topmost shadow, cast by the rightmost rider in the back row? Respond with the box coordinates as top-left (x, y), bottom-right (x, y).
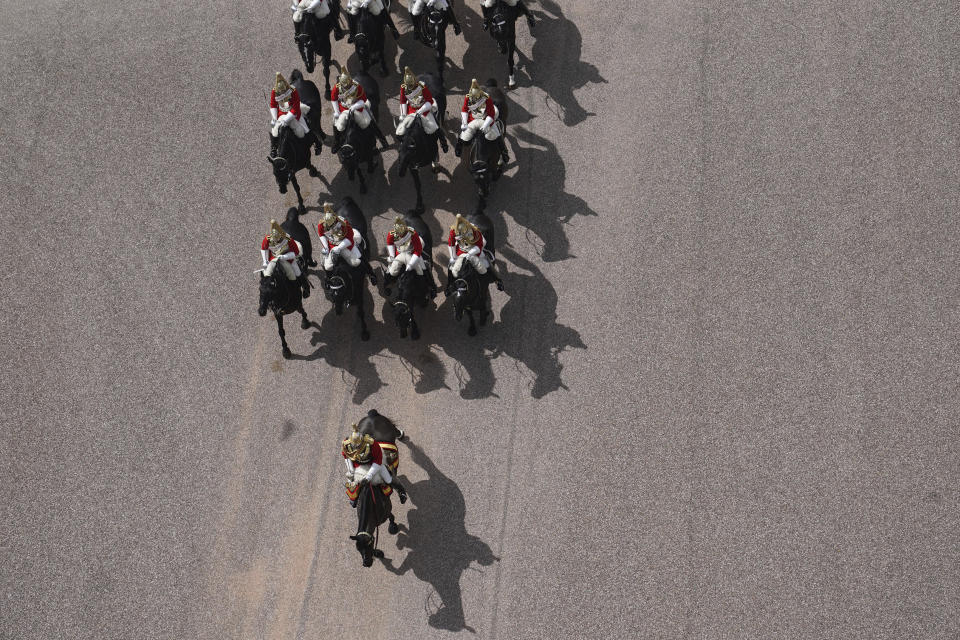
top-left (530, 0), bottom-right (607, 127)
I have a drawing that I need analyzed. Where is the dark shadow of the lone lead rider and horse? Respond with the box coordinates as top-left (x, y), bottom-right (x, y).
top-left (383, 443), bottom-right (500, 633)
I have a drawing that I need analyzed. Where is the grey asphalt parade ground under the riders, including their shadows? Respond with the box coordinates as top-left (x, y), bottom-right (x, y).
top-left (0, 0), bottom-right (960, 640)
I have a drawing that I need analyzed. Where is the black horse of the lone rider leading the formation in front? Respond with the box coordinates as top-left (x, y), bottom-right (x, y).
top-left (350, 409), bottom-right (406, 567)
